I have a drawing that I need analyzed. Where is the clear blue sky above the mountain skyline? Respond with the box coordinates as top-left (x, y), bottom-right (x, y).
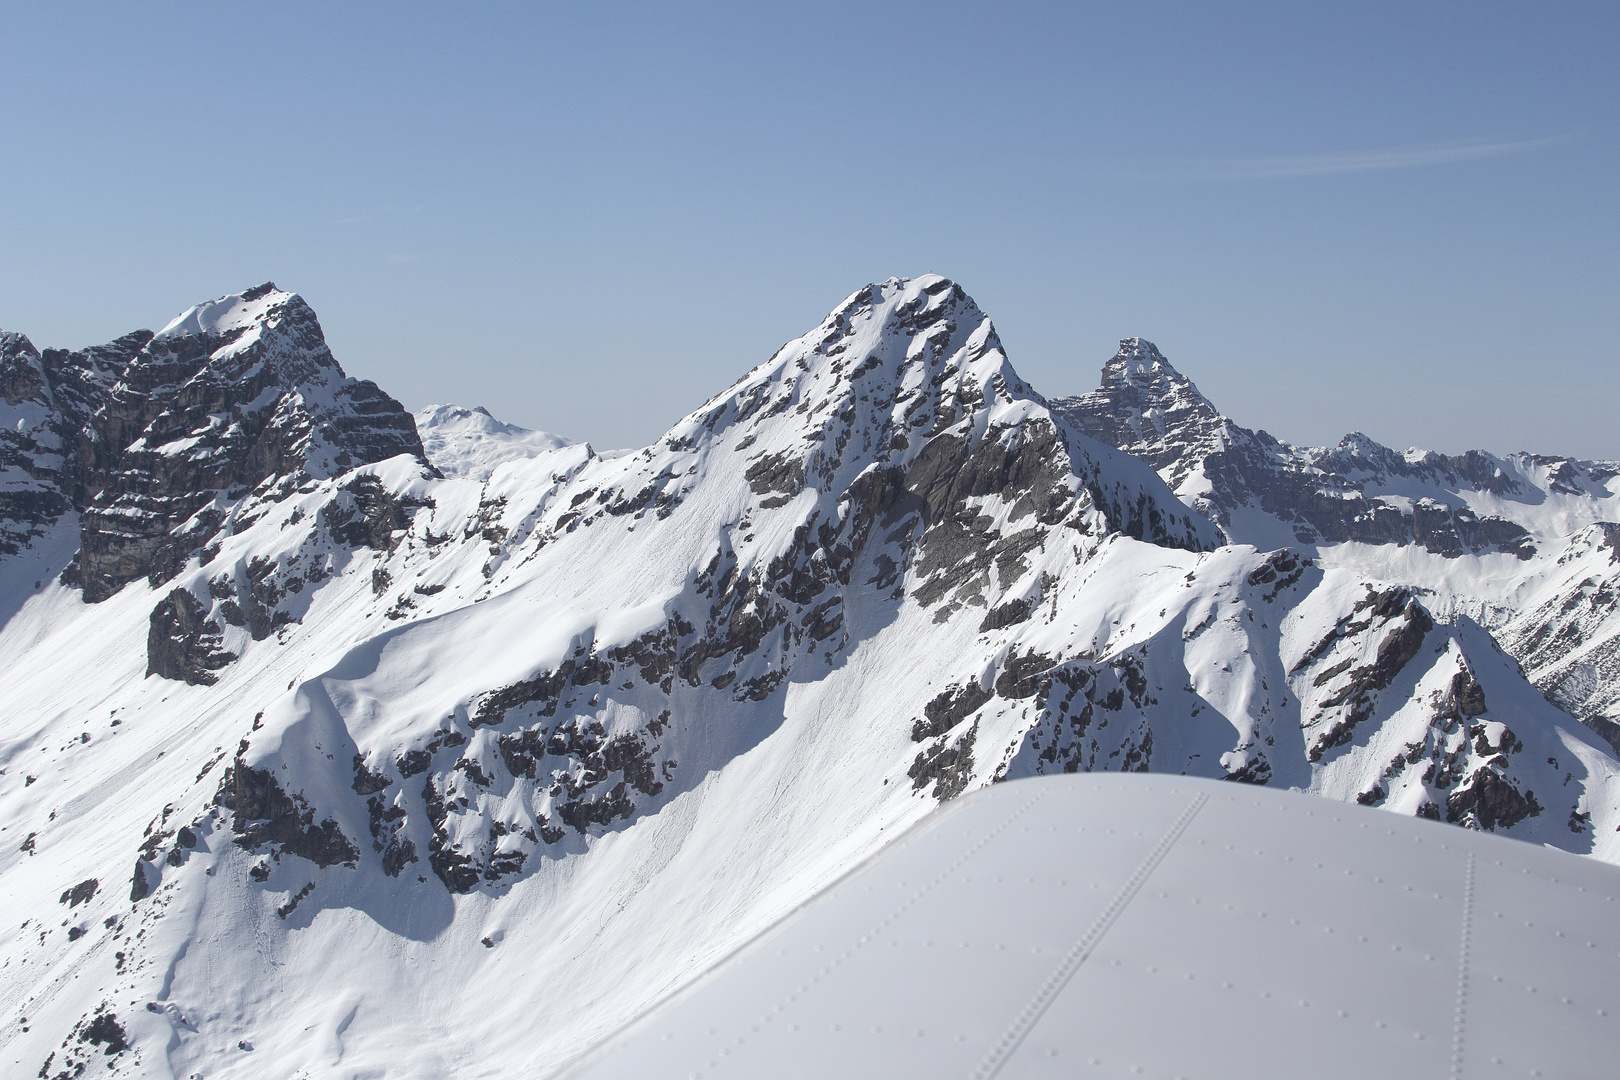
top-left (0, 3), bottom-right (1620, 457)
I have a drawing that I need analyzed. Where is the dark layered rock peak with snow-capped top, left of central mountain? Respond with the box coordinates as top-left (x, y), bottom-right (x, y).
top-left (78, 285), bottom-right (421, 601)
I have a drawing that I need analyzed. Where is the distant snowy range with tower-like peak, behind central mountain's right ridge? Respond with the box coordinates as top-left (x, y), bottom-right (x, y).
top-left (1053, 338), bottom-right (1620, 745)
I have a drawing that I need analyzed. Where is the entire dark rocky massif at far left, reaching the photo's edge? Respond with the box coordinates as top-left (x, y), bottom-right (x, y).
top-left (0, 285), bottom-right (423, 602)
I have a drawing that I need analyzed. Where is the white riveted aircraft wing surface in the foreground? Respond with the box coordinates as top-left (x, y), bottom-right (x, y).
top-left (572, 776), bottom-right (1620, 1080)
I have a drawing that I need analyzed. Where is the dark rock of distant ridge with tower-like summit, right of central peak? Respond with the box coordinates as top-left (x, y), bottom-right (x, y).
top-left (1051, 338), bottom-right (1536, 559)
